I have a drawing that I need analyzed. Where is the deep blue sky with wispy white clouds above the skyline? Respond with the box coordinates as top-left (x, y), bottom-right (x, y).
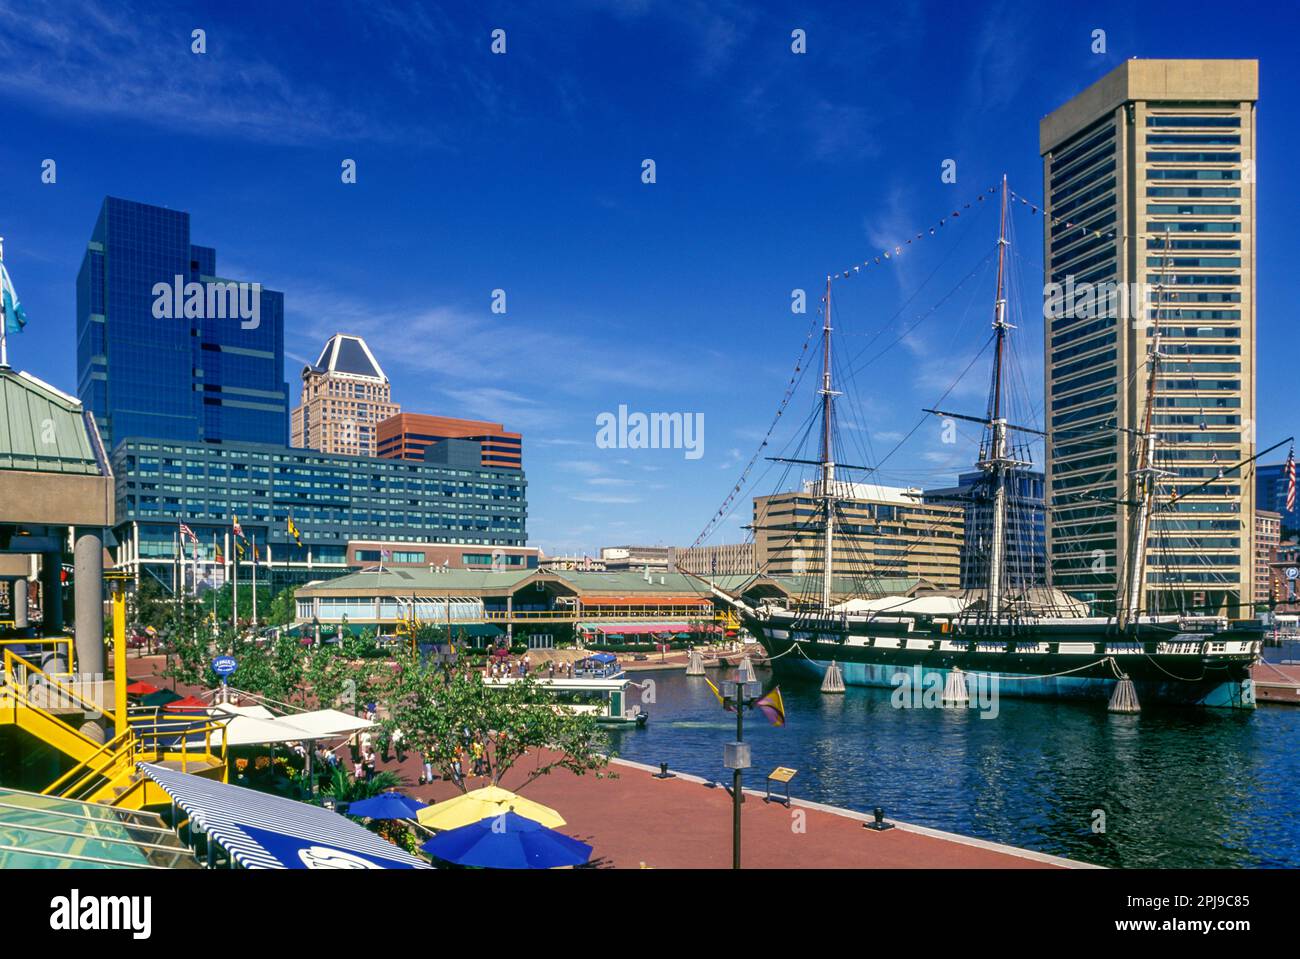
top-left (0, 0), bottom-right (1300, 552)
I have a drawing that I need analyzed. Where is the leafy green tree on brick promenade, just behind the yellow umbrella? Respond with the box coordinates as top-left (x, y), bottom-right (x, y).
top-left (382, 652), bottom-right (608, 791)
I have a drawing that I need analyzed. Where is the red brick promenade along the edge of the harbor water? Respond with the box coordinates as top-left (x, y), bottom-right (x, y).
top-left (127, 658), bottom-right (1082, 869)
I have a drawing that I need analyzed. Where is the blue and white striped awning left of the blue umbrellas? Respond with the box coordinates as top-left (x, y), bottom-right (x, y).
top-left (140, 763), bottom-right (430, 869)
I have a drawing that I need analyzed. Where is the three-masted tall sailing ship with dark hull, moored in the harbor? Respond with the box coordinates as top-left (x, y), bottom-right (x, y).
top-left (712, 177), bottom-right (1264, 711)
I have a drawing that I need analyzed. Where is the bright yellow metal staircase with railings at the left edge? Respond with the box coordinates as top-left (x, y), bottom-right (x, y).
top-left (0, 641), bottom-right (228, 810)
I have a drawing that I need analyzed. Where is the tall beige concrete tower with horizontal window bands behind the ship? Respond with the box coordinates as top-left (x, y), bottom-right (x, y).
top-left (1039, 60), bottom-right (1258, 616)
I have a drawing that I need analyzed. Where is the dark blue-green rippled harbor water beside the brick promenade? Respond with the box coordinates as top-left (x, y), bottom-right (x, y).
top-left (611, 660), bottom-right (1300, 868)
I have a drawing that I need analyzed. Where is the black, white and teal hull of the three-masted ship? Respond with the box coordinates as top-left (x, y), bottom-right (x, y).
top-left (744, 608), bottom-right (1260, 710)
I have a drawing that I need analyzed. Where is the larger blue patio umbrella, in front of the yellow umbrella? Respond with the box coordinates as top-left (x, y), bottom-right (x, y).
top-left (420, 812), bottom-right (592, 869)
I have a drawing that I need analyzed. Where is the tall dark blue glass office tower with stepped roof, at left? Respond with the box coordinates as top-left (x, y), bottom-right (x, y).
top-left (77, 196), bottom-right (289, 448)
